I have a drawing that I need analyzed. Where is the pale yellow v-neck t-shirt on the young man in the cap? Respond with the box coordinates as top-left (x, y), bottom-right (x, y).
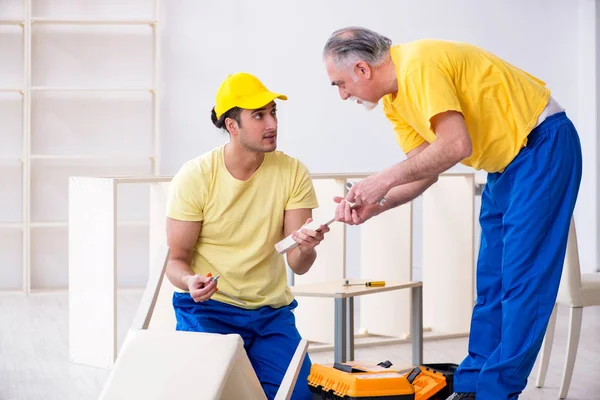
top-left (167, 146), bottom-right (318, 309)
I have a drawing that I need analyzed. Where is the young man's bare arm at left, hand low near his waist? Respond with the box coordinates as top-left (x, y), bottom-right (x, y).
top-left (166, 217), bottom-right (217, 302)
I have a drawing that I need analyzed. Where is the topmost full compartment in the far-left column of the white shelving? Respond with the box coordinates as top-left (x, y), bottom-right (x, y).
top-left (0, 25), bottom-right (23, 89)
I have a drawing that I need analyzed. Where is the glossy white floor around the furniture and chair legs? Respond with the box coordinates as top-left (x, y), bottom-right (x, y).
top-left (0, 291), bottom-right (600, 400)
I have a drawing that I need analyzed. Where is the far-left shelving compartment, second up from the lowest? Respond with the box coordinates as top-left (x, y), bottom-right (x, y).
top-left (0, 160), bottom-right (23, 223)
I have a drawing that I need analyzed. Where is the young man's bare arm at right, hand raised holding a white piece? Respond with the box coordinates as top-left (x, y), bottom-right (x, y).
top-left (283, 208), bottom-right (329, 275)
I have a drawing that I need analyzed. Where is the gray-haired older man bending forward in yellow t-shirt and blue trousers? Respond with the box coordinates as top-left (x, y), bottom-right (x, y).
top-left (323, 27), bottom-right (582, 400)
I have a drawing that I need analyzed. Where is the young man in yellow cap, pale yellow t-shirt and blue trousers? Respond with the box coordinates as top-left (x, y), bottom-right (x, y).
top-left (167, 73), bottom-right (329, 399)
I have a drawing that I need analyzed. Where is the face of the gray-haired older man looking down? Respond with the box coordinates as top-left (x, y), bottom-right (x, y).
top-left (325, 57), bottom-right (379, 110)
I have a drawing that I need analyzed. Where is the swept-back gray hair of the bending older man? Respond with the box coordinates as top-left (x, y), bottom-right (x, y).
top-left (323, 26), bottom-right (392, 67)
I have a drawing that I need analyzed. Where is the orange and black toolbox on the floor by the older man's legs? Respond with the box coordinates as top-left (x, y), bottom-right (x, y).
top-left (308, 361), bottom-right (453, 400)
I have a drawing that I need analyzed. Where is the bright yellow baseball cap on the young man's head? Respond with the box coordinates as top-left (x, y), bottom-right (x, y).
top-left (215, 72), bottom-right (287, 118)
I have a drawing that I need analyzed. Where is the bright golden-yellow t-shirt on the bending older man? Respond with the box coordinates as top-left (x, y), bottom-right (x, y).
top-left (383, 39), bottom-right (550, 172)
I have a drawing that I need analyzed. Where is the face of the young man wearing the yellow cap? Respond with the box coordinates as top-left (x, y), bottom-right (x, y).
top-left (238, 101), bottom-right (277, 153)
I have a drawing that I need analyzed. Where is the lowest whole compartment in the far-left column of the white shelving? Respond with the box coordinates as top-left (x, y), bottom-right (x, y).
top-left (0, 228), bottom-right (23, 290)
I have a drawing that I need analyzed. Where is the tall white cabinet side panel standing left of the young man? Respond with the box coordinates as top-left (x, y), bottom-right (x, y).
top-left (68, 178), bottom-right (117, 368)
